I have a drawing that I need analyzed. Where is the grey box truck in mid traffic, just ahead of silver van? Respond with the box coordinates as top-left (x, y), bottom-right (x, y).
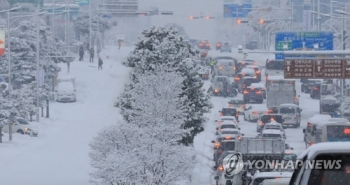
top-left (266, 79), bottom-right (299, 113)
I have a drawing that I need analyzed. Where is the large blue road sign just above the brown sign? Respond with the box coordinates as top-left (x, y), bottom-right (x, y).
top-left (275, 31), bottom-right (334, 60)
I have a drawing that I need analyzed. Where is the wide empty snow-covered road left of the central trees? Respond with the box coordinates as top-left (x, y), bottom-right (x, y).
top-left (0, 47), bottom-right (131, 185)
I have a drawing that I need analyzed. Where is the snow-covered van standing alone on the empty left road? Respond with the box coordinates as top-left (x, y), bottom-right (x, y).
top-left (56, 77), bottom-right (77, 102)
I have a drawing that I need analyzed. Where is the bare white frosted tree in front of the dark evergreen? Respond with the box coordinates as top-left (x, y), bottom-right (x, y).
top-left (90, 68), bottom-right (195, 185)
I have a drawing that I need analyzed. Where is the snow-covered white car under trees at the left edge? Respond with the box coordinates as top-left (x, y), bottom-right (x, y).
top-left (2, 119), bottom-right (38, 136)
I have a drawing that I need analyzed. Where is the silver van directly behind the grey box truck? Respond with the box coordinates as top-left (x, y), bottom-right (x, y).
top-left (278, 104), bottom-right (302, 128)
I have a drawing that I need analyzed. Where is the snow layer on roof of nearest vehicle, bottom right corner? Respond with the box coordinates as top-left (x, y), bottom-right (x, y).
top-left (298, 142), bottom-right (350, 159)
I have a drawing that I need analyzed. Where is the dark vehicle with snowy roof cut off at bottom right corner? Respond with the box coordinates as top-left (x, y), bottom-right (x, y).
top-left (289, 142), bottom-right (350, 185)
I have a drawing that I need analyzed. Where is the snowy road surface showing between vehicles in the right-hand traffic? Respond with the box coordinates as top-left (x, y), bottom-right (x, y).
top-left (192, 49), bottom-right (319, 185)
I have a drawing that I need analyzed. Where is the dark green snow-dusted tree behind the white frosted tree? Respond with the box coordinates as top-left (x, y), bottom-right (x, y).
top-left (117, 27), bottom-right (212, 144)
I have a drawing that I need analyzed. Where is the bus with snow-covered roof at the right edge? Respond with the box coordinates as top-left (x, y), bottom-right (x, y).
top-left (303, 115), bottom-right (350, 148)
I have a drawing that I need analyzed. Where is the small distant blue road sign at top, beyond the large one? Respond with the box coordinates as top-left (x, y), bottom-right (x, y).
top-left (224, 4), bottom-right (252, 18)
